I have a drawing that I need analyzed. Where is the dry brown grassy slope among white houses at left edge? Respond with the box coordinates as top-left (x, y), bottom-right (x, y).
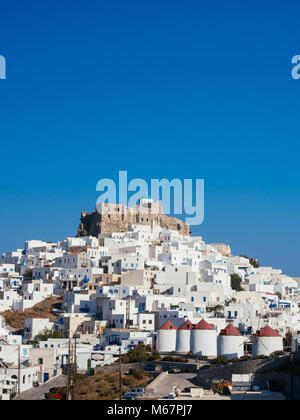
top-left (1, 297), bottom-right (61, 331)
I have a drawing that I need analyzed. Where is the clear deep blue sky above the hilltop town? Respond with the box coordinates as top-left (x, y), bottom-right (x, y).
top-left (0, 0), bottom-right (300, 276)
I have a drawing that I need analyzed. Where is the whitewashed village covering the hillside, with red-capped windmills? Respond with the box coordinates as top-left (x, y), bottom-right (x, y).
top-left (0, 199), bottom-right (300, 400)
